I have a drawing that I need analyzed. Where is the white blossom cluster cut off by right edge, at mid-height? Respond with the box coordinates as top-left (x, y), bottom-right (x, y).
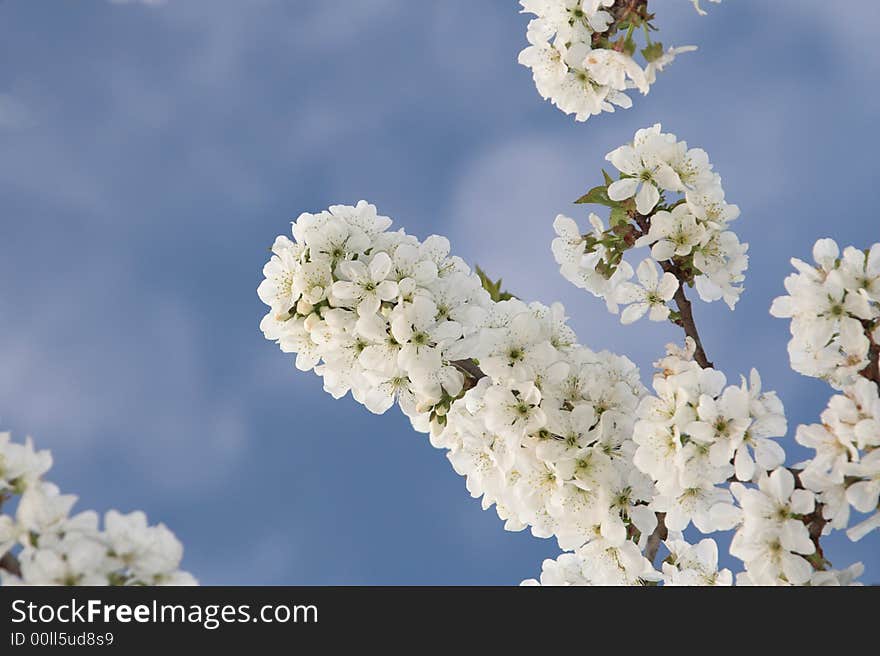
top-left (770, 239), bottom-right (880, 390)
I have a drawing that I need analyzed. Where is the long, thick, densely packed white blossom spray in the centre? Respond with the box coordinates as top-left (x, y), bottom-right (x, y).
top-left (258, 201), bottom-right (656, 564)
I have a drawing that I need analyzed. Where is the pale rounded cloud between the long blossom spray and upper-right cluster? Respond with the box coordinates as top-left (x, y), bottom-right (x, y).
top-left (445, 134), bottom-right (679, 368)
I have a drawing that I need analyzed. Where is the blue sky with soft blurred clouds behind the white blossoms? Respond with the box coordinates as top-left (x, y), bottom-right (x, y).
top-left (0, 0), bottom-right (880, 584)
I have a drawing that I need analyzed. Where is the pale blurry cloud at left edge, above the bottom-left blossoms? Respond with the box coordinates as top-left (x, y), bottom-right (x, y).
top-left (0, 254), bottom-right (249, 494)
